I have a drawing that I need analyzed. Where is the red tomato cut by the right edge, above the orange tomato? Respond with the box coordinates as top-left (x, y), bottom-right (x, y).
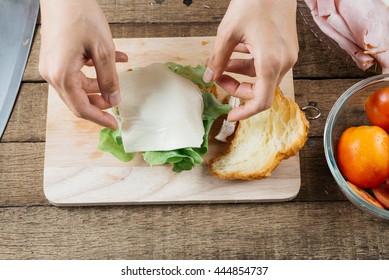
top-left (365, 87), bottom-right (389, 132)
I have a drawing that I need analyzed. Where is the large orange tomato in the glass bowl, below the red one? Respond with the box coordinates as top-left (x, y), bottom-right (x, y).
top-left (336, 126), bottom-right (389, 188)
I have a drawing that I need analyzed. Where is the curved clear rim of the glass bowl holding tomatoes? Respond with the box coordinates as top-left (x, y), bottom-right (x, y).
top-left (324, 74), bottom-right (389, 220)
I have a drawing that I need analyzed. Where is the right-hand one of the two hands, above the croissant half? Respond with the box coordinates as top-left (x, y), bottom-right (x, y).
top-left (203, 0), bottom-right (299, 122)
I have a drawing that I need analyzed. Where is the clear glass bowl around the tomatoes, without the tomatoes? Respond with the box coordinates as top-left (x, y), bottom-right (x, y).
top-left (324, 74), bottom-right (389, 220)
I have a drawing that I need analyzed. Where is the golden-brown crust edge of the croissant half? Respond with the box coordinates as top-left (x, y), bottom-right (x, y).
top-left (208, 87), bottom-right (309, 180)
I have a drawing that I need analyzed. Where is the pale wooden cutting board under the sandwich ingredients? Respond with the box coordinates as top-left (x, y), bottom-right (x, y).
top-left (44, 37), bottom-right (300, 206)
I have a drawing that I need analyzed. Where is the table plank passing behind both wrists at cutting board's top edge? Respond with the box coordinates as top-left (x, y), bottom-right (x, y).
top-left (23, 17), bottom-right (372, 81)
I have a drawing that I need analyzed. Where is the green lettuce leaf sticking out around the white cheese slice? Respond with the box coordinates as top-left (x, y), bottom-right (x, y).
top-left (99, 62), bottom-right (230, 173)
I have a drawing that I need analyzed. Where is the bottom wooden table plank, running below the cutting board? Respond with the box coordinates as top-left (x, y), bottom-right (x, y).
top-left (0, 202), bottom-right (389, 259)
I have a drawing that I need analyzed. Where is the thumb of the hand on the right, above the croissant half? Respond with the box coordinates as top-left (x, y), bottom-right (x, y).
top-left (203, 32), bottom-right (239, 83)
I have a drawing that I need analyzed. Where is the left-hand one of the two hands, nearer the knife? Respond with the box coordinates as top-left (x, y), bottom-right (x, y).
top-left (39, 0), bottom-right (128, 129)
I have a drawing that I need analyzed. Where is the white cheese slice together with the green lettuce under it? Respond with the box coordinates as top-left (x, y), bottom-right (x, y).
top-left (99, 63), bottom-right (230, 173)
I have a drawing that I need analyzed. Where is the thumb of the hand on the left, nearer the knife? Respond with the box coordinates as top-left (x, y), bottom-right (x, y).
top-left (92, 44), bottom-right (120, 106)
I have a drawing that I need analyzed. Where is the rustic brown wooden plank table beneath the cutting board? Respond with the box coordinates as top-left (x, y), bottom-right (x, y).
top-left (0, 0), bottom-right (389, 259)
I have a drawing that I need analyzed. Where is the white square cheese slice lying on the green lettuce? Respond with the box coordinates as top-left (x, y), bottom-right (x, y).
top-left (119, 63), bottom-right (204, 153)
